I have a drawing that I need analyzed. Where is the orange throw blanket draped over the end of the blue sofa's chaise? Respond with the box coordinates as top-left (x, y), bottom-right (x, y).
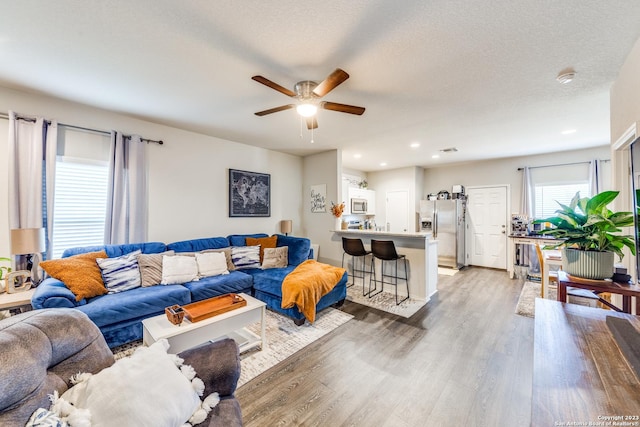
top-left (281, 259), bottom-right (346, 323)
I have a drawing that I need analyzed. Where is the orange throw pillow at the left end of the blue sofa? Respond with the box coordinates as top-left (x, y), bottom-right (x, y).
top-left (40, 251), bottom-right (108, 301)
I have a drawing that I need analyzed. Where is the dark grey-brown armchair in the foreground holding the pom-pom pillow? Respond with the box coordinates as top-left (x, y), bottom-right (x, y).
top-left (0, 308), bottom-right (242, 426)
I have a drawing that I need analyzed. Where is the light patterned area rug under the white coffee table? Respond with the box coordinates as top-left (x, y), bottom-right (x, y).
top-left (113, 308), bottom-right (353, 387)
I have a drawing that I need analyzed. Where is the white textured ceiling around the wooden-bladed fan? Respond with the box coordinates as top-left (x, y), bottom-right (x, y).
top-left (0, 0), bottom-right (640, 171)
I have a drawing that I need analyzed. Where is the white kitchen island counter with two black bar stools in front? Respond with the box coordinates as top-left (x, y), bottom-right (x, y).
top-left (331, 230), bottom-right (438, 301)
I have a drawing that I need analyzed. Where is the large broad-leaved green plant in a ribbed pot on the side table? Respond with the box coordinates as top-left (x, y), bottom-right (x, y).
top-left (534, 191), bottom-right (636, 280)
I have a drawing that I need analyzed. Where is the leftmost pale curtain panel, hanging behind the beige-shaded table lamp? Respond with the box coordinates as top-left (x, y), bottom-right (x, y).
top-left (9, 111), bottom-right (58, 258)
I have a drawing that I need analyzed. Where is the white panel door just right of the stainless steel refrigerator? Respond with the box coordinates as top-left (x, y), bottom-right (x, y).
top-left (467, 186), bottom-right (508, 269)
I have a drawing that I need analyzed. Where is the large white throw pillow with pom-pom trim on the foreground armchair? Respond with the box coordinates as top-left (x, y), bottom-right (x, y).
top-left (51, 339), bottom-right (219, 427)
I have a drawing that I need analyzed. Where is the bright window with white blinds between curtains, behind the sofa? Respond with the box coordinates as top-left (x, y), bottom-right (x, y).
top-left (52, 156), bottom-right (109, 259)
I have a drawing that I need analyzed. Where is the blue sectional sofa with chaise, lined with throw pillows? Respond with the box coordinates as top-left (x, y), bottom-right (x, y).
top-left (31, 233), bottom-right (347, 347)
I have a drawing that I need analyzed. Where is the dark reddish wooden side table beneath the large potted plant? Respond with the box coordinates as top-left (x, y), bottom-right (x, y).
top-left (558, 271), bottom-right (640, 315)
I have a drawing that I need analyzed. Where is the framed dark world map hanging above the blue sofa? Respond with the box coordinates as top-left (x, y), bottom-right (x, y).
top-left (229, 169), bottom-right (271, 217)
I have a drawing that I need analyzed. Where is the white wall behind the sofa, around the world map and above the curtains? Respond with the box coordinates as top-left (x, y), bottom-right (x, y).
top-left (0, 87), bottom-right (303, 256)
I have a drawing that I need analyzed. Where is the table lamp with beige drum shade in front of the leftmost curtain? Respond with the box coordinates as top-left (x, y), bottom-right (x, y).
top-left (6, 228), bottom-right (47, 293)
